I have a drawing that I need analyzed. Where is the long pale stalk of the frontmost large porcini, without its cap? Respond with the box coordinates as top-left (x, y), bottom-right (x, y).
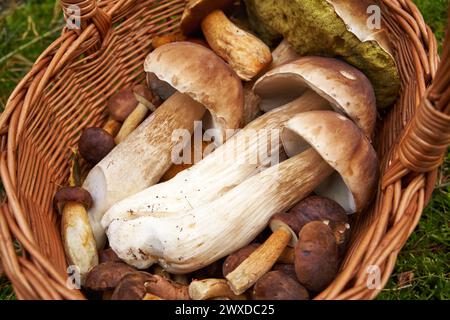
top-left (107, 146), bottom-right (333, 273)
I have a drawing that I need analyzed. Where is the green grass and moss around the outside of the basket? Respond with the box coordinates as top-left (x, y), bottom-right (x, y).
top-left (0, 0), bottom-right (450, 300)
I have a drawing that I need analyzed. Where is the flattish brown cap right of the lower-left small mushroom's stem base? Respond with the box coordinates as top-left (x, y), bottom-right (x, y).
top-left (84, 262), bottom-right (136, 291)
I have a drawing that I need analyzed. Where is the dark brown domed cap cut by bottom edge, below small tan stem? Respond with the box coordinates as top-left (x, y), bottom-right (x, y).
top-left (252, 271), bottom-right (309, 300)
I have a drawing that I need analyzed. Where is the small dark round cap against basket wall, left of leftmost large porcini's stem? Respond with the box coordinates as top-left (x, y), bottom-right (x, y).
top-left (78, 128), bottom-right (116, 165)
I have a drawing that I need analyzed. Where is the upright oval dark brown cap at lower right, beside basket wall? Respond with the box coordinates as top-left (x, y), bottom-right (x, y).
top-left (295, 221), bottom-right (339, 292)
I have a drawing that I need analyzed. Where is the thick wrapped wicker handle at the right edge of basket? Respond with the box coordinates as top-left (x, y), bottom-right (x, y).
top-left (398, 8), bottom-right (450, 173)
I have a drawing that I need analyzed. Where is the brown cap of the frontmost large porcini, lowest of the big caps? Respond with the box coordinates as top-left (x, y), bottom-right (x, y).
top-left (281, 111), bottom-right (378, 213)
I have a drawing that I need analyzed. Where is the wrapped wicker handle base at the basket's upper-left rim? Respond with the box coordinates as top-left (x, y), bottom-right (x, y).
top-left (59, 0), bottom-right (112, 41)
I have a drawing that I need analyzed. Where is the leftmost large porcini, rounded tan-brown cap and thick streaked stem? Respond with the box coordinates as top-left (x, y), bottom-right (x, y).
top-left (84, 42), bottom-right (243, 248)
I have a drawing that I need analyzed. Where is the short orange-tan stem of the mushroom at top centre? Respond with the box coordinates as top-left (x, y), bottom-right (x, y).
top-left (202, 10), bottom-right (272, 81)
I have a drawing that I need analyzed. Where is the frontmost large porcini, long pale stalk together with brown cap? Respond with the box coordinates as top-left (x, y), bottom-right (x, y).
top-left (103, 111), bottom-right (376, 276)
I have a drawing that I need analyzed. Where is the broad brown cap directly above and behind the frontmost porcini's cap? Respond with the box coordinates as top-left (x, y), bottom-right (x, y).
top-left (253, 57), bottom-right (377, 137)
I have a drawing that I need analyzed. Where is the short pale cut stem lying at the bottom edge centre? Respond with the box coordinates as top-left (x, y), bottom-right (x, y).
top-left (189, 279), bottom-right (247, 300)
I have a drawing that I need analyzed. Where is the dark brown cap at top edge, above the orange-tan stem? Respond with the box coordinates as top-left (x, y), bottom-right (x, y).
top-left (180, 0), bottom-right (234, 35)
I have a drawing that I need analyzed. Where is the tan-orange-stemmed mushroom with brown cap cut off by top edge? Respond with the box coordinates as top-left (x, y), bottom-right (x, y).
top-left (180, 0), bottom-right (272, 81)
